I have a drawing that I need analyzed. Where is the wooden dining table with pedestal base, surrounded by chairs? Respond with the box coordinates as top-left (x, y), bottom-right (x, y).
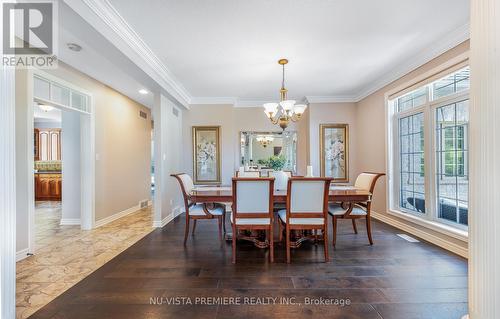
top-left (189, 185), bottom-right (372, 248)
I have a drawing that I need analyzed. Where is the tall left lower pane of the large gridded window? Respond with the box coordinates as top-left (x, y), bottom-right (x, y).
top-left (398, 113), bottom-right (425, 213)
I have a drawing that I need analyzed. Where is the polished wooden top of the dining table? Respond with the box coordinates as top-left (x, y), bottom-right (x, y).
top-left (190, 186), bottom-right (372, 203)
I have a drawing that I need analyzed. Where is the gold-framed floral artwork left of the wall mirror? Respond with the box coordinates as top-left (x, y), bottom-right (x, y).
top-left (193, 126), bottom-right (221, 184)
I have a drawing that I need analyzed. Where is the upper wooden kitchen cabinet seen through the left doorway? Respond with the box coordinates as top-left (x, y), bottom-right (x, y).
top-left (34, 128), bottom-right (61, 161)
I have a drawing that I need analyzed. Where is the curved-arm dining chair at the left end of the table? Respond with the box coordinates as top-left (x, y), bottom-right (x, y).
top-left (170, 173), bottom-right (226, 246)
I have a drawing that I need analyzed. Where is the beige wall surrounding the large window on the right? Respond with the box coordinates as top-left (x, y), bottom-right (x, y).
top-left (354, 41), bottom-right (469, 255)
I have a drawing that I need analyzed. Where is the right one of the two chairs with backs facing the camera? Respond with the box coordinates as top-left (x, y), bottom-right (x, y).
top-left (278, 177), bottom-right (331, 263)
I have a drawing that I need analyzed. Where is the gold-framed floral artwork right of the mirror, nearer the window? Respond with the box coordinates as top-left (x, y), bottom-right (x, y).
top-left (319, 124), bottom-right (349, 183)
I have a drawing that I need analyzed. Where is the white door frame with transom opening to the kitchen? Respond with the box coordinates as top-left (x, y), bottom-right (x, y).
top-left (27, 70), bottom-right (95, 254)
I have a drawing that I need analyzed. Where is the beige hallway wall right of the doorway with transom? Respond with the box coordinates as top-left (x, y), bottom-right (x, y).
top-left (47, 63), bottom-right (151, 221)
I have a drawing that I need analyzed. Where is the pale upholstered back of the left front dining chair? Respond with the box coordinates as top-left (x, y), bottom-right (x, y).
top-left (233, 177), bottom-right (274, 219)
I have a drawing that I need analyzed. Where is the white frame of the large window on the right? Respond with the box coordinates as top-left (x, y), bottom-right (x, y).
top-left (385, 53), bottom-right (469, 241)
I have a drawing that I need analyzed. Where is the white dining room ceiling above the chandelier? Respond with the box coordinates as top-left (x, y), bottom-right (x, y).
top-left (104, 0), bottom-right (469, 102)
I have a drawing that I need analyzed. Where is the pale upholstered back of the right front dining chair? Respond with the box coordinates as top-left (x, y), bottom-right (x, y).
top-left (286, 177), bottom-right (332, 223)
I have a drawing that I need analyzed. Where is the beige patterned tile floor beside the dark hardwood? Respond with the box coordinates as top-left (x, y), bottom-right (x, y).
top-left (16, 201), bottom-right (153, 318)
